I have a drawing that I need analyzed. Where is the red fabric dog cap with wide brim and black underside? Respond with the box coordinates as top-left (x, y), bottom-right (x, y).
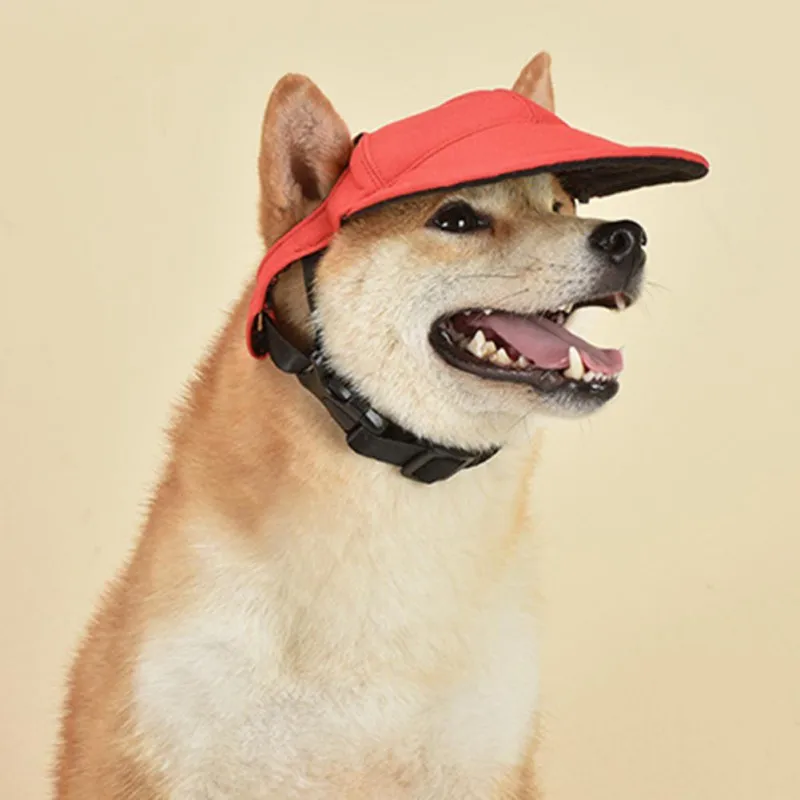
top-left (247, 89), bottom-right (708, 355)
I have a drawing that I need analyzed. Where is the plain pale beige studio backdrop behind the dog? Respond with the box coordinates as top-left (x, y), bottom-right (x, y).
top-left (0, 0), bottom-right (800, 800)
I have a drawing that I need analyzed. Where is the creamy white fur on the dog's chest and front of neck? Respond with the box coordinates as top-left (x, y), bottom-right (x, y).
top-left (134, 430), bottom-right (537, 800)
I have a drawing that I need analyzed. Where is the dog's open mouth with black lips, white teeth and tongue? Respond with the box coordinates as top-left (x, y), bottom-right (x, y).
top-left (430, 292), bottom-right (632, 400)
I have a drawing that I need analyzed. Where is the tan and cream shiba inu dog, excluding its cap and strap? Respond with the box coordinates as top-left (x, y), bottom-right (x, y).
top-left (56, 54), bottom-right (708, 800)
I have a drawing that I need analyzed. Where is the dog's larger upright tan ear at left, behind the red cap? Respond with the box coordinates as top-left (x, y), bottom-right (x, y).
top-left (258, 75), bottom-right (352, 247)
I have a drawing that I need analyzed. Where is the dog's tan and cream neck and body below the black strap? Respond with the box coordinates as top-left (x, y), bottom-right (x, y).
top-left (56, 296), bottom-right (537, 800)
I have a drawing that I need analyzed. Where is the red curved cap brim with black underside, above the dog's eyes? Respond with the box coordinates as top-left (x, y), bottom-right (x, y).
top-left (347, 117), bottom-right (709, 216)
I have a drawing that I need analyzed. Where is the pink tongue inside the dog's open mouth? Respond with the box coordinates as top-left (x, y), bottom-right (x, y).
top-left (480, 313), bottom-right (623, 375)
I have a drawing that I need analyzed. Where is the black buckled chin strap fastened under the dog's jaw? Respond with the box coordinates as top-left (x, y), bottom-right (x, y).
top-left (251, 252), bottom-right (497, 483)
